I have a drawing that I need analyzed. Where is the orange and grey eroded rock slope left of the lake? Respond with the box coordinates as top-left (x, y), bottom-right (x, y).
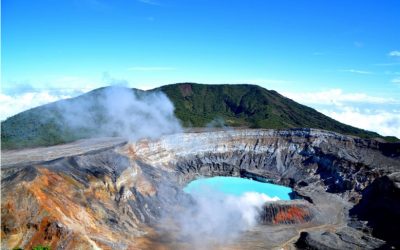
top-left (2, 149), bottom-right (181, 249)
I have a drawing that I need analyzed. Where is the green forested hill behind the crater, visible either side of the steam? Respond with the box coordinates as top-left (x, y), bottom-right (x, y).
top-left (1, 83), bottom-right (398, 149)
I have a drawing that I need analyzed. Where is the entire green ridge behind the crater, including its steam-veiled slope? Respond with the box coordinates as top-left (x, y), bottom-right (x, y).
top-left (1, 83), bottom-right (398, 149)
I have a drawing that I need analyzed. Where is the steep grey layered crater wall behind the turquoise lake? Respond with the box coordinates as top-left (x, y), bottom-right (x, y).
top-left (131, 129), bottom-right (399, 193)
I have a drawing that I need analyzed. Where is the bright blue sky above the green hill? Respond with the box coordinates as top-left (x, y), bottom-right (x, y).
top-left (1, 0), bottom-right (400, 136)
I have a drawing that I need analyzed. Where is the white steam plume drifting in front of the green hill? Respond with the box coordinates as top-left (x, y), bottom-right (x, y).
top-left (58, 87), bottom-right (182, 141)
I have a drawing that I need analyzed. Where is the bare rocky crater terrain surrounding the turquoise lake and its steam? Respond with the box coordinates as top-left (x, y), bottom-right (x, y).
top-left (1, 129), bottom-right (400, 249)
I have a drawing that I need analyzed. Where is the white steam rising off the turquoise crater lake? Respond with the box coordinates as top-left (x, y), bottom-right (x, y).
top-left (178, 189), bottom-right (279, 249)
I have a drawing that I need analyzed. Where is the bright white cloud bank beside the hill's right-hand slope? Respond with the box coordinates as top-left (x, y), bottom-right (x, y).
top-left (283, 89), bottom-right (400, 138)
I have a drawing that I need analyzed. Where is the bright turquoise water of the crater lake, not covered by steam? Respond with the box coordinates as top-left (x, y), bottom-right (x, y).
top-left (183, 176), bottom-right (292, 200)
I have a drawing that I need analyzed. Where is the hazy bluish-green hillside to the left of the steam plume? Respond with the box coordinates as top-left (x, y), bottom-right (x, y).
top-left (1, 89), bottom-right (103, 149)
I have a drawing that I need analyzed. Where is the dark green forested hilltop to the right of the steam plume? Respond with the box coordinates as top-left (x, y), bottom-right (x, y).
top-left (156, 83), bottom-right (390, 141)
